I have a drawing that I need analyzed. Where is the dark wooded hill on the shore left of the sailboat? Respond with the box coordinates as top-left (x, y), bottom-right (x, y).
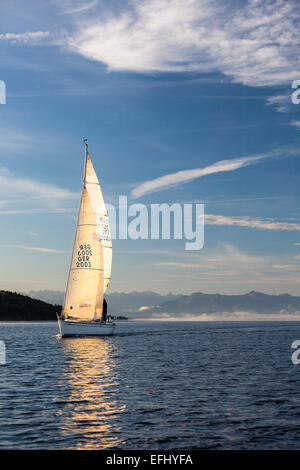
top-left (0, 290), bottom-right (61, 321)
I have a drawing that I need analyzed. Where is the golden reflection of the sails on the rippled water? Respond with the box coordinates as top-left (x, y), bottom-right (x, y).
top-left (55, 338), bottom-right (126, 449)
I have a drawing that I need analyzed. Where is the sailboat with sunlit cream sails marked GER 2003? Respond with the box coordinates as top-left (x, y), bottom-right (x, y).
top-left (57, 139), bottom-right (115, 337)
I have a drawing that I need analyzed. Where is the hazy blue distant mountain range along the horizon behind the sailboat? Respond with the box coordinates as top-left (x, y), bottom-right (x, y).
top-left (28, 290), bottom-right (300, 319)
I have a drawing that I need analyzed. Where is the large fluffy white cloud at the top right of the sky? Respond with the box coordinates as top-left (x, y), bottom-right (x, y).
top-left (67, 0), bottom-right (300, 86)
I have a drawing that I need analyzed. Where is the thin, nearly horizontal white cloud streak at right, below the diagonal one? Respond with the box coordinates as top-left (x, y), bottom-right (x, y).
top-left (204, 214), bottom-right (300, 231)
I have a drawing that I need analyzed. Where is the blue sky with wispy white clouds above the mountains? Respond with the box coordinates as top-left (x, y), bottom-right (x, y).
top-left (0, 0), bottom-right (300, 295)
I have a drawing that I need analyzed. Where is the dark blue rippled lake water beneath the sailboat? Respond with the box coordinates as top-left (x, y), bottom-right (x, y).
top-left (0, 321), bottom-right (300, 450)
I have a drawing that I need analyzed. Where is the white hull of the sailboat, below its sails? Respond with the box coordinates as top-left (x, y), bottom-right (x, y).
top-left (58, 318), bottom-right (116, 338)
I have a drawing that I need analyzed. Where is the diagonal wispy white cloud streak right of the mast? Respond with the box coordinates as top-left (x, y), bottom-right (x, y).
top-left (131, 148), bottom-right (297, 199)
